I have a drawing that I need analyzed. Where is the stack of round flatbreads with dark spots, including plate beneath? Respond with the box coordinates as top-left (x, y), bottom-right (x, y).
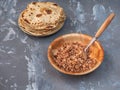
top-left (18, 2), bottom-right (66, 36)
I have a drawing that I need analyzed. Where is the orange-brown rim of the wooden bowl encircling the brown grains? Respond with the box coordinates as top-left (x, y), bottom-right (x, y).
top-left (47, 33), bottom-right (104, 75)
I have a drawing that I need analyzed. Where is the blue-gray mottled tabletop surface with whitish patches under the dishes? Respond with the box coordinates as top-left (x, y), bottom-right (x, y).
top-left (0, 0), bottom-right (120, 90)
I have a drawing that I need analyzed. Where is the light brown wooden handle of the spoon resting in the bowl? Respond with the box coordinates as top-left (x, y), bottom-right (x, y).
top-left (95, 13), bottom-right (115, 38)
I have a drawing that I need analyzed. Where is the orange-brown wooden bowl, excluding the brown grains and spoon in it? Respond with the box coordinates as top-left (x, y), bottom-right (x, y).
top-left (48, 33), bottom-right (104, 75)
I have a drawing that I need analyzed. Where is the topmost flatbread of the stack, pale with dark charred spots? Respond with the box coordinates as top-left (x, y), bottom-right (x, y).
top-left (21, 2), bottom-right (66, 30)
